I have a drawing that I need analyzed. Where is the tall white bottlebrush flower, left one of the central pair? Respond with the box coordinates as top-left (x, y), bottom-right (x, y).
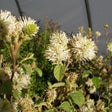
top-left (45, 32), bottom-right (70, 64)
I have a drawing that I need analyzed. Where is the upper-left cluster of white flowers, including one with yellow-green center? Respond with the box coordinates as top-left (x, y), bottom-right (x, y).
top-left (0, 10), bottom-right (39, 42)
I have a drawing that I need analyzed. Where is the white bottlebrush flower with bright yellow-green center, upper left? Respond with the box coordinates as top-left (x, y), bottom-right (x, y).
top-left (19, 17), bottom-right (39, 37)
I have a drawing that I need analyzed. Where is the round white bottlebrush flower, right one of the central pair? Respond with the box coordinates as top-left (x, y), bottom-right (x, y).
top-left (70, 33), bottom-right (96, 61)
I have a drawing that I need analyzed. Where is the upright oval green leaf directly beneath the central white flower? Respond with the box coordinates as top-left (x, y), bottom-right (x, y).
top-left (54, 65), bottom-right (65, 81)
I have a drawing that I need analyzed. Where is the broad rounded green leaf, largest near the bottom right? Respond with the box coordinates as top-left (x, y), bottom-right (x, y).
top-left (70, 90), bottom-right (85, 107)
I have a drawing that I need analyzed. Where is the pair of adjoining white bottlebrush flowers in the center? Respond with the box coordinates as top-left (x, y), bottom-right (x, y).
top-left (45, 32), bottom-right (97, 64)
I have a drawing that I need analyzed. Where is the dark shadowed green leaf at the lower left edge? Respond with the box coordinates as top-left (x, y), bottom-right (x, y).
top-left (0, 80), bottom-right (12, 94)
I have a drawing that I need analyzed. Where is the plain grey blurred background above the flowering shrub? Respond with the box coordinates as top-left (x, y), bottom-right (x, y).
top-left (0, 0), bottom-right (112, 53)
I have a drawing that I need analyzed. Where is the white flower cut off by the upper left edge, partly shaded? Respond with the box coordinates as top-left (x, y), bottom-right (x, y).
top-left (0, 10), bottom-right (16, 41)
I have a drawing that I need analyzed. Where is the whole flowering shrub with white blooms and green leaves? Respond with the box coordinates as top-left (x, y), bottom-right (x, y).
top-left (0, 11), bottom-right (112, 112)
